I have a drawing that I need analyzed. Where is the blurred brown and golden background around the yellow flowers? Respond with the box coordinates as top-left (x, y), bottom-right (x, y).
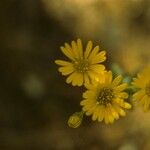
top-left (0, 0), bottom-right (150, 150)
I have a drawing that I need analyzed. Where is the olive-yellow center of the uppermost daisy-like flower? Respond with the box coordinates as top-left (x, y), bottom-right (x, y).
top-left (73, 59), bottom-right (89, 73)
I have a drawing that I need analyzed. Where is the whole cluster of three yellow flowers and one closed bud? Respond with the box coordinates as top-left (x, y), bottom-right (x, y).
top-left (55, 39), bottom-right (150, 128)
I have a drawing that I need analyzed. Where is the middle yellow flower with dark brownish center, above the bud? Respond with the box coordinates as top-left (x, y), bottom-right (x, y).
top-left (80, 71), bottom-right (131, 124)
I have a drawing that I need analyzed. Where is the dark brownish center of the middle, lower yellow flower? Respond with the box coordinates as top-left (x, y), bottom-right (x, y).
top-left (97, 87), bottom-right (114, 106)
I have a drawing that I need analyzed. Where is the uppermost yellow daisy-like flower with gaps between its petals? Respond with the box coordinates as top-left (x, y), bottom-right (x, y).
top-left (55, 39), bottom-right (106, 86)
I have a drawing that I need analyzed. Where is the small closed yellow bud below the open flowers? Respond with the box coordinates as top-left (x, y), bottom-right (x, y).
top-left (68, 111), bottom-right (83, 128)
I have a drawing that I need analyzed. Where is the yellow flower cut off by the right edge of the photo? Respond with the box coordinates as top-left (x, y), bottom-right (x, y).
top-left (132, 65), bottom-right (150, 111)
